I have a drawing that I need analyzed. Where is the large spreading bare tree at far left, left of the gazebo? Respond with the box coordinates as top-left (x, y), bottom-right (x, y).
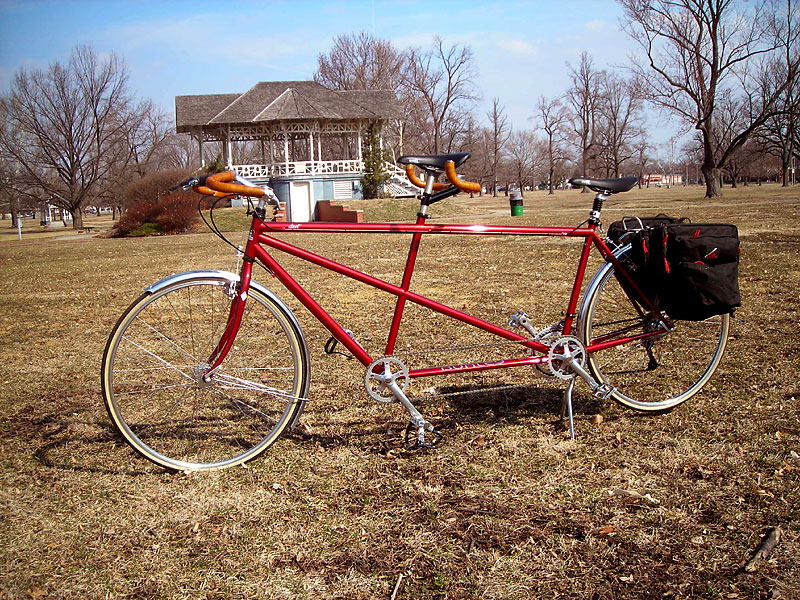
top-left (0, 46), bottom-right (131, 228)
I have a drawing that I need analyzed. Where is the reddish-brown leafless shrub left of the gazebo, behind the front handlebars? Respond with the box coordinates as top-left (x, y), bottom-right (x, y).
top-left (115, 170), bottom-right (198, 237)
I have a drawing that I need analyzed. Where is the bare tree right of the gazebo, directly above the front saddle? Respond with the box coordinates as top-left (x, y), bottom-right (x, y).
top-left (401, 36), bottom-right (478, 154)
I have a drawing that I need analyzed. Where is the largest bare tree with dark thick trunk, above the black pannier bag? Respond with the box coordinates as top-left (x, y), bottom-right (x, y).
top-left (620, 0), bottom-right (800, 197)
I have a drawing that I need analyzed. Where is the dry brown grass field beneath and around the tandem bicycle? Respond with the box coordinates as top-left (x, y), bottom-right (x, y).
top-left (0, 185), bottom-right (800, 600)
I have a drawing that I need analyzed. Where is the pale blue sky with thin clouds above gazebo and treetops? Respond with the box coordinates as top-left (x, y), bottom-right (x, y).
top-left (0, 0), bottom-right (676, 148)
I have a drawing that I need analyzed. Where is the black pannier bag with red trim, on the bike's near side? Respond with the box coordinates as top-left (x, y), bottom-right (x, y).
top-left (631, 223), bottom-right (741, 321)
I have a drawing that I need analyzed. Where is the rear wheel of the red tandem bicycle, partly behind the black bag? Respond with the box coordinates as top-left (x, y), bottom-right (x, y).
top-left (579, 251), bottom-right (730, 412)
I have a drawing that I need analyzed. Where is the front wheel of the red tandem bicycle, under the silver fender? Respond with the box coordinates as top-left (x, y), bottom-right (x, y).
top-left (101, 273), bottom-right (309, 470)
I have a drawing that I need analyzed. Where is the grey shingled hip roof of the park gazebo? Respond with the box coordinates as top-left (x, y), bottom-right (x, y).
top-left (175, 81), bottom-right (402, 133)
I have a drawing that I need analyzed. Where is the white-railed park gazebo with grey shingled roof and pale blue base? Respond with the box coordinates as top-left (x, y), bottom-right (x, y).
top-left (175, 81), bottom-right (413, 221)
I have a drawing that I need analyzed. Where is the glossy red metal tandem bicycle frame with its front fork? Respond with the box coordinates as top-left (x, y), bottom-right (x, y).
top-left (207, 211), bottom-right (661, 378)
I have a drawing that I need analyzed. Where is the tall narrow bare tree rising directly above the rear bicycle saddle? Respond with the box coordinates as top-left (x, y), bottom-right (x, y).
top-left (567, 52), bottom-right (603, 180)
